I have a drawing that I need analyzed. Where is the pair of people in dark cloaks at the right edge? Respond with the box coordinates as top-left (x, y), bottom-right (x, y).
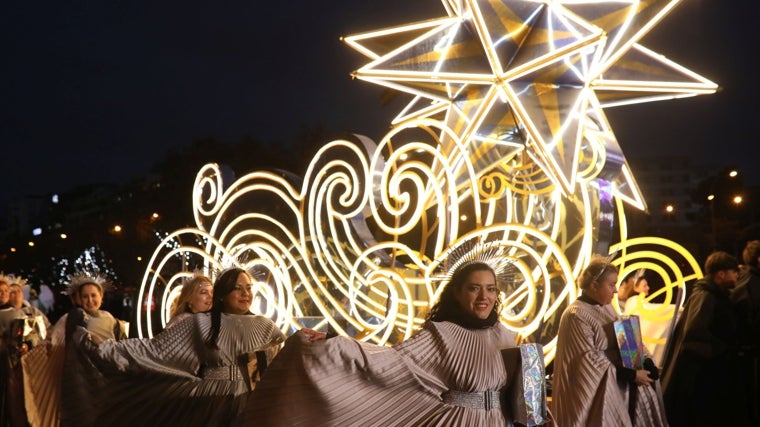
top-left (662, 249), bottom-right (760, 426)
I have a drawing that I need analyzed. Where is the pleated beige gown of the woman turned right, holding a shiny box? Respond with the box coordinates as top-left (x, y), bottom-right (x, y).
top-left (552, 296), bottom-right (667, 427)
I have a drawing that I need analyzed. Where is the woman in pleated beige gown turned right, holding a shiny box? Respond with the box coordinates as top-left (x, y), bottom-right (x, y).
top-left (552, 255), bottom-right (667, 427)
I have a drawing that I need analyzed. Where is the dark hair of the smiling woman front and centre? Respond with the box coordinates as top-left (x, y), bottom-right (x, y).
top-left (426, 262), bottom-right (501, 329)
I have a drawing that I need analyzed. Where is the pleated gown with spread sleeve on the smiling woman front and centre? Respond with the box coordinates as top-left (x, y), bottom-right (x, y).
top-left (239, 322), bottom-right (515, 427)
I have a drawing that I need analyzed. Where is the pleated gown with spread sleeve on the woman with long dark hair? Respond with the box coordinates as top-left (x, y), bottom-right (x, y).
top-left (62, 313), bottom-right (284, 426)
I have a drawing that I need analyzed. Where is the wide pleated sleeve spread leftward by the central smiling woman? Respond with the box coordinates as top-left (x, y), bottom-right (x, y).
top-left (240, 332), bottom-right (440, 426)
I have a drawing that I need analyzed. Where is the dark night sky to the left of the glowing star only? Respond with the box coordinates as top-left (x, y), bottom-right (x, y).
top-left (0, 0), bottom-right (444, 205)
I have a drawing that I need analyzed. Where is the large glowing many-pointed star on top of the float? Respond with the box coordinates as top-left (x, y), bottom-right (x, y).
top-left (345, 0), bottom-right (717, 209)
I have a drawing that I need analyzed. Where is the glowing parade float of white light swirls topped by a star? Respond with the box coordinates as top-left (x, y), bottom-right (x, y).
top-left (137, 0), bottom-right (716, 361)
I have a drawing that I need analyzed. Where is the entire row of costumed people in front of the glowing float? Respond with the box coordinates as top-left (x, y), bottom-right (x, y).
top-left (0, 246), bottom-right (760, 426)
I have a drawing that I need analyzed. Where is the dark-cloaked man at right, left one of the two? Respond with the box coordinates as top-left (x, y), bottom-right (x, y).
top-left (662, 252), bottom-right (746, 426)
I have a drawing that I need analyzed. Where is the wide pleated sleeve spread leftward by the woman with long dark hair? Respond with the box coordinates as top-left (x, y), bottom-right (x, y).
top-left (61, 319), bottom-right (200, 427)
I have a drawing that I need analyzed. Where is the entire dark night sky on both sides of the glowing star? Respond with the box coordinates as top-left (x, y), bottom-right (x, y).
top-left (0, 0), bottom-right (760, 207)
